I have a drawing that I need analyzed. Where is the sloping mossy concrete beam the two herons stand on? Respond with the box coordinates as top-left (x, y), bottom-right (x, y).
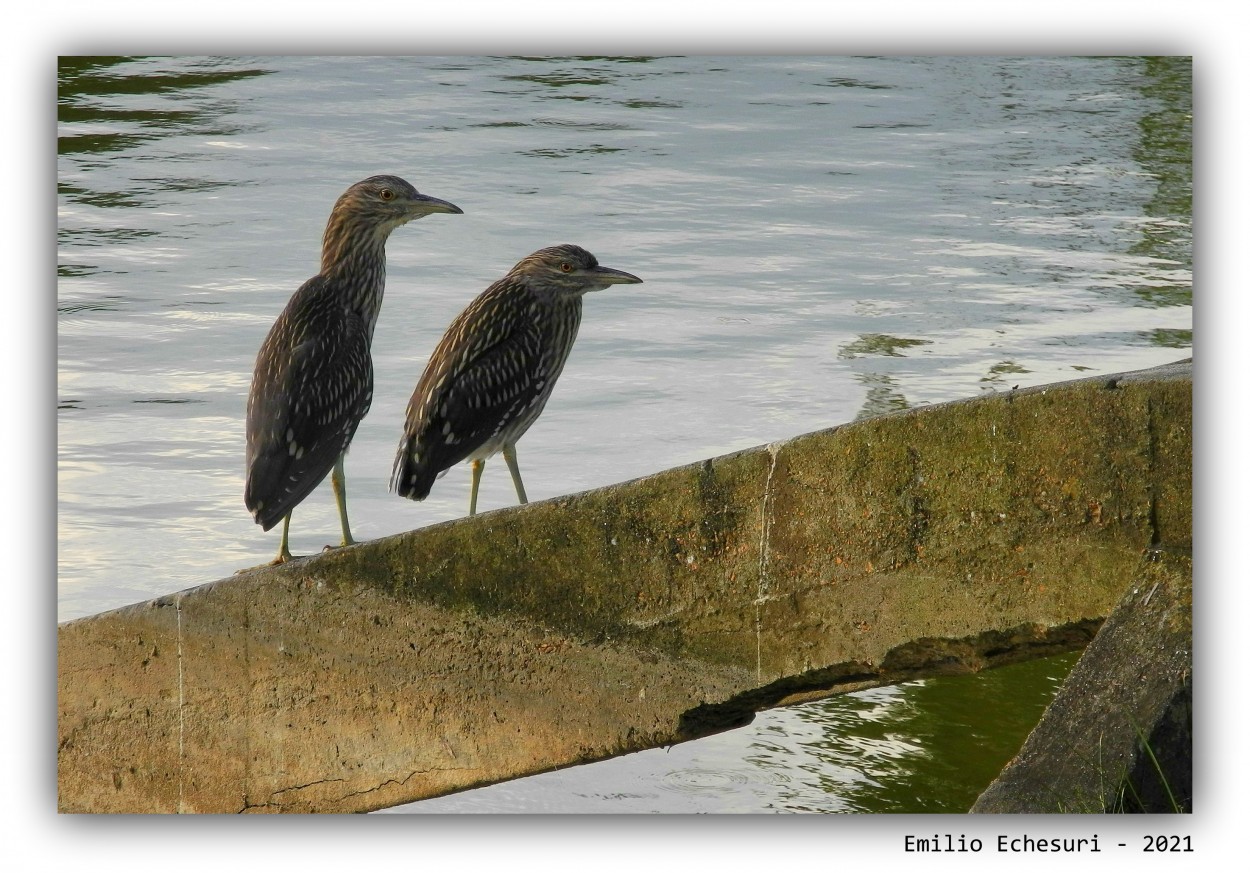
top-left (59, 363), bottom-right (1191, 812)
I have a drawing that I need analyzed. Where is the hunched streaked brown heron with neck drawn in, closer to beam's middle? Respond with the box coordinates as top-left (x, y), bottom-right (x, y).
top-left (391, 245), bottom-right (643, 515)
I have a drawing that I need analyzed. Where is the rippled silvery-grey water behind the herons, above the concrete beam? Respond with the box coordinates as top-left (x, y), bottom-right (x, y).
top-left (58, 56), bottom-right (1193, 808)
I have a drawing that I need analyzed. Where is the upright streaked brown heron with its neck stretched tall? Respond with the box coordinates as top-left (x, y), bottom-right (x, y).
top-left (244, 176), bottom-right (461, 564)
